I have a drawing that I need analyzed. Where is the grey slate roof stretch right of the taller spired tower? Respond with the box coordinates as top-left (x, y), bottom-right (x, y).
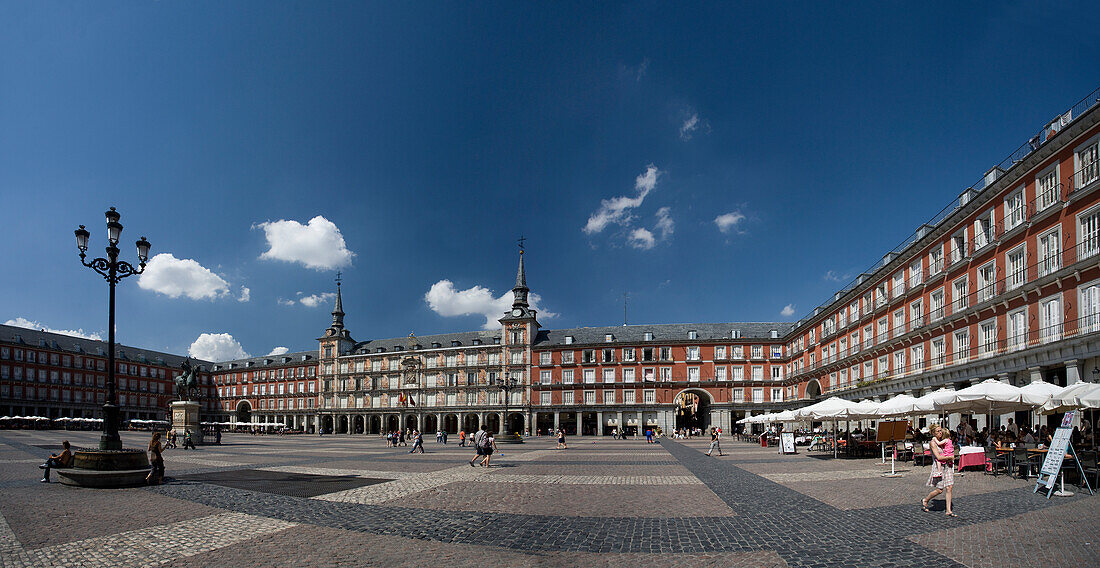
top-left (535, 321), bottom-right (794, 349)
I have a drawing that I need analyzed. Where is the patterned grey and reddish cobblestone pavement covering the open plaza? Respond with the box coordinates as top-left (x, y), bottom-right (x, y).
top-left (0, 432), bottom-right (1100, 568)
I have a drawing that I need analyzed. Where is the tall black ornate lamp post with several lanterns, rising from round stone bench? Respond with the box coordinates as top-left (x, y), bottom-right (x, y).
top-left (74, 207), bottom-right (150, 450)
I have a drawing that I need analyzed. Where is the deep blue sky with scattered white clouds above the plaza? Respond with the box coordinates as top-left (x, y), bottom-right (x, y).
top-left (0, 1), bottom-right (1100, 357)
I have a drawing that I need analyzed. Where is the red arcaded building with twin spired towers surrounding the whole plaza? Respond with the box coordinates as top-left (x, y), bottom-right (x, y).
top-left (0, 89), bottom-right (1100, 435)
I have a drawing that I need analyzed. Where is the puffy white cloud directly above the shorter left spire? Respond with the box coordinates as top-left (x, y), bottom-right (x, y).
top-left (253, 215), bottom-right (355, 270)
